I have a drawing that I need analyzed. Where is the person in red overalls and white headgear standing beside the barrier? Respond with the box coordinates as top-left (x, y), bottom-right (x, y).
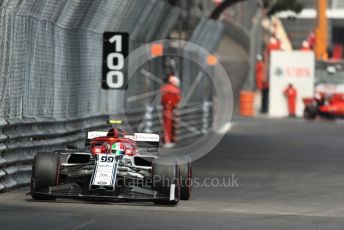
top-left (160, 75), bottom-right (182, 148)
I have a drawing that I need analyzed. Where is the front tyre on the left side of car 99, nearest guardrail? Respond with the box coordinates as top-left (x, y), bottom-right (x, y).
top-left (31, 153), bottom-right (60, 200)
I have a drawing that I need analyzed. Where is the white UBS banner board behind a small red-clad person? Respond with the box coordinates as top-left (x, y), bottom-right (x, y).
top-left (269, 51), bottom-right (315, 117)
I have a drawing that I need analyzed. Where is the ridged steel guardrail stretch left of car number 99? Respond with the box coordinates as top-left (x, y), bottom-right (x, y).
top-left (0, 116), bottom-right (108, 192)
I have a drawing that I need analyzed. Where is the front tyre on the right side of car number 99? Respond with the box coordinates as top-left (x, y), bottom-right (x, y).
top-left (152, 160), bottom-right (180, 205)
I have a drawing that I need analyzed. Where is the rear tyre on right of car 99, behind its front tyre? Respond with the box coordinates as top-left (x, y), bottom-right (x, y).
top-left (179, 157), bottom-right (192, 200)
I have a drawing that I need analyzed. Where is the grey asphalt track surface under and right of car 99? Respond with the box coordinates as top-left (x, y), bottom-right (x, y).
top-left (0, 118), bottom-right (344, 230)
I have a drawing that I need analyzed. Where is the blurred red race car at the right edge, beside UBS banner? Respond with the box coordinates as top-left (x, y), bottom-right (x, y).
top-left (303, 93), bottom-right (344, 119)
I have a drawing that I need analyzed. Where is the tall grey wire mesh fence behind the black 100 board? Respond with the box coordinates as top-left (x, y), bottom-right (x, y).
top-left (0, 0), bottom-right (179, 118)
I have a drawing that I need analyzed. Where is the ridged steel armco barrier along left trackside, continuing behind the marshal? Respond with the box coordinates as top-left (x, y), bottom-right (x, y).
top-left (0, 103), bottom-right (213, 192)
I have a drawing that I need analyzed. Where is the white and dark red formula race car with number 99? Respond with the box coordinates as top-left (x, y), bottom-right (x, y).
top-left (28, 123), bottom-right (191, 205)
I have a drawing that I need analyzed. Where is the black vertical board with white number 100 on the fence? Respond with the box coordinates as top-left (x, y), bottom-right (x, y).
top-left (102, 32), bottom-right (129, 90)
